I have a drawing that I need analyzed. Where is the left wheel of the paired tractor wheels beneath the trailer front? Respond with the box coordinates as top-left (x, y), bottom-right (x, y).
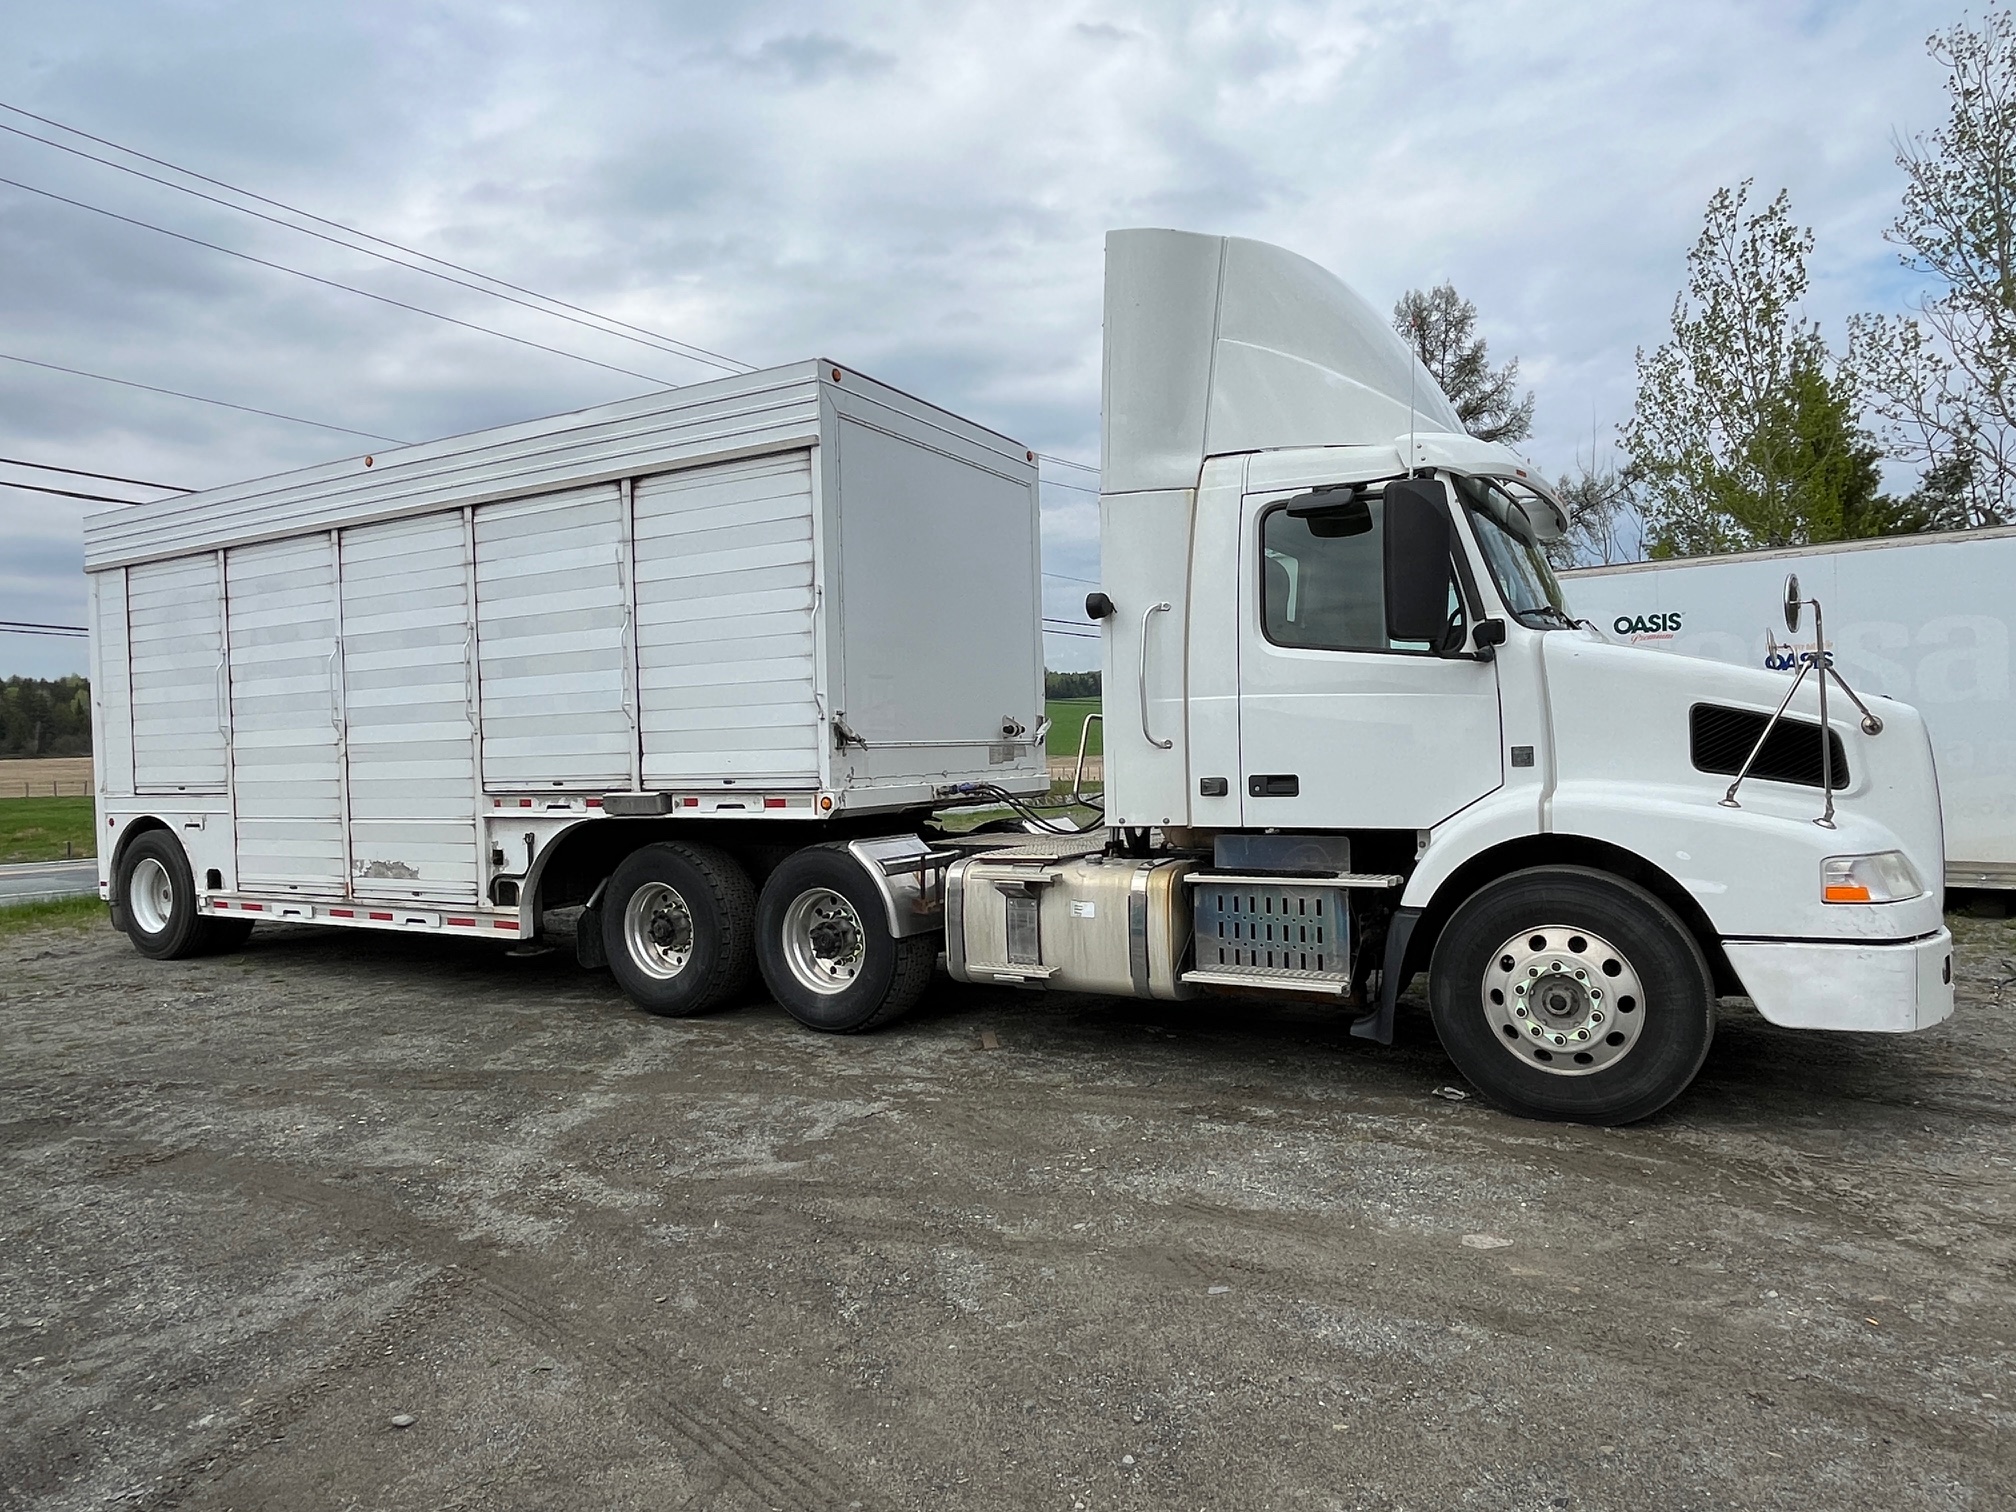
top-left (603, 841), bottom-right (756, 1016)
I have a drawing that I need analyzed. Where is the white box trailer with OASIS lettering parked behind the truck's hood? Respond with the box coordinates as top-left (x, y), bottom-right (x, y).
top-left (1562, 528), bottom-right (2016, 889)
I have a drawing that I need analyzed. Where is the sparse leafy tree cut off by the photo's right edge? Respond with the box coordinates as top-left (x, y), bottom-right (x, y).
top-left (1849, 10), bottom-right (2016, 524)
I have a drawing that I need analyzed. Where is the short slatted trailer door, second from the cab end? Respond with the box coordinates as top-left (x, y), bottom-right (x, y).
top-left (476, 484), bottom-right (635, 788)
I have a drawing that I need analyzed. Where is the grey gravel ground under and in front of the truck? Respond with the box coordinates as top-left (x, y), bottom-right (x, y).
top-left (0, 919), bottom-right (2016, 1512)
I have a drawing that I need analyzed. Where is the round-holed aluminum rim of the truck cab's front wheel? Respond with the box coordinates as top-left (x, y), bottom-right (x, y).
top-left (1482, 923), bottom-right (1645, 1077)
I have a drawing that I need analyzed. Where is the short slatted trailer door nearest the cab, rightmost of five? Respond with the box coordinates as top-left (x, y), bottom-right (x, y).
top-left (635, 452), bottom-right (821, 784)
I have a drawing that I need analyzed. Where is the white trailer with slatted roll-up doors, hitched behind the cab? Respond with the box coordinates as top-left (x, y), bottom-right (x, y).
top-left (87, 363), bottom-right (1048, 1040)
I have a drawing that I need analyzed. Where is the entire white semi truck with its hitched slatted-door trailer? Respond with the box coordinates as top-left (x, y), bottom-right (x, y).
top-left (85, 230), bottom-right (1954, 1123)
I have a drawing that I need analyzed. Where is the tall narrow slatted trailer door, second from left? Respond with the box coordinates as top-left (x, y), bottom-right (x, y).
top-left (224, 534), bottom-right (343, 893)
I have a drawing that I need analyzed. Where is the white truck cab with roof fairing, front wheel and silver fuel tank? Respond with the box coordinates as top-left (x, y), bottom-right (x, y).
top-left (948, 230), bottom-right (1954, 1123)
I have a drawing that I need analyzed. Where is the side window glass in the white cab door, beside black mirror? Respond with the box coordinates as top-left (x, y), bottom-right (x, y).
top-left (1260, 500), bottom-right (1415, 651)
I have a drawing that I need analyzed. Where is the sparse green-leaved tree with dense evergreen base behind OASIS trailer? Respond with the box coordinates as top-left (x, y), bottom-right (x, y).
top-left (1623, 179), bottom-right (1917, 556)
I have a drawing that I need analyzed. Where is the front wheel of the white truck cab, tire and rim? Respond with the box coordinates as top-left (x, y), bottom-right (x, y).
top-left (1427, 867), bottom-right (1716, 1123)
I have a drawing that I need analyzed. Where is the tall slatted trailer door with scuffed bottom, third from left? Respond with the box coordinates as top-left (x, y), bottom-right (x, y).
top-left (343, 510), bottom-right (478, 901)
